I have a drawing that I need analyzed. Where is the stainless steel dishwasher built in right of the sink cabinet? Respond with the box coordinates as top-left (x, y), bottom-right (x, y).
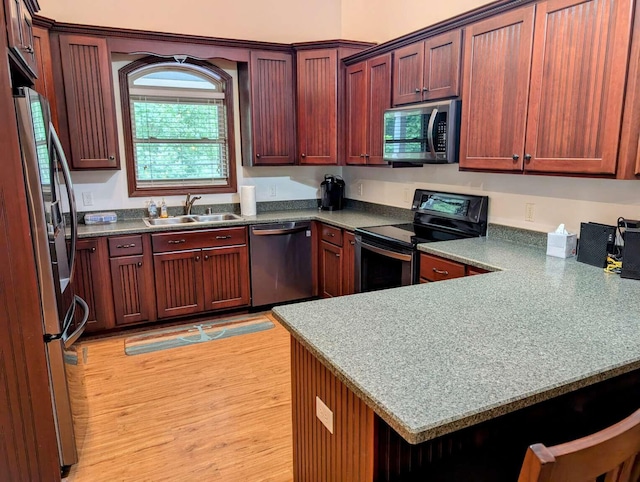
top-left (249, 222), bottom-right (313, 306)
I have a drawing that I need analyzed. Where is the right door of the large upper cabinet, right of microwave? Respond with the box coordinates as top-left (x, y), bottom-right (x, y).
top-left (524, 0), bottom-right (632, 174)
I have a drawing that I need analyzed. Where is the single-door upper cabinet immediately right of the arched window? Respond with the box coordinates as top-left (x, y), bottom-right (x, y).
top-left (238, 51), bottom-right (296, 166)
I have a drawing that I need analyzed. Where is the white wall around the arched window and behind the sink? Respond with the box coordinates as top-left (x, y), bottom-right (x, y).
top-left (71, 55), bottom-right (341, 212)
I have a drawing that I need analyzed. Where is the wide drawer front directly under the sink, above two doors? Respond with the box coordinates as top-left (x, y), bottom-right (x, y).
top-left (151, 227), bottom-right (247, 253)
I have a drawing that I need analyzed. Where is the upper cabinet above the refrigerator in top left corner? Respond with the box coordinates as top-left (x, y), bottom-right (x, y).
top-left (4, 0), bottom-right (38, 77)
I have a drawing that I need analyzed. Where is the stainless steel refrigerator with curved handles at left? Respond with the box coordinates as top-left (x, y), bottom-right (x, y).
top-left (15, 88), bottom-right (89, 468)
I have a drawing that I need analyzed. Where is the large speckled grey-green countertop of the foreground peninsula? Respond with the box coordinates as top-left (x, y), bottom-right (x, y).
top-left (273, 237), bottom-right (640, 443)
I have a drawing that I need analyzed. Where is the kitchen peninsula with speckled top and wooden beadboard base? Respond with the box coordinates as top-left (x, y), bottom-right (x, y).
top-left (274, 235), bottom-right (640, 482)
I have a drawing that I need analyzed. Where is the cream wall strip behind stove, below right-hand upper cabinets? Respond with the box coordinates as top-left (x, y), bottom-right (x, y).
top-left (343, 164), bottom-right (640, 232)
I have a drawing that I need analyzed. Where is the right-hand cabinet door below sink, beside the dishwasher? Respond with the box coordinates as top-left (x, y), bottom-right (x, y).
top-left (202, 245), bottom-right (251, 311)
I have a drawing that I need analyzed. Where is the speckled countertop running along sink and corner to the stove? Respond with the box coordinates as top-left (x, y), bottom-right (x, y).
top-left (78, 209), bottom-right (406, 238)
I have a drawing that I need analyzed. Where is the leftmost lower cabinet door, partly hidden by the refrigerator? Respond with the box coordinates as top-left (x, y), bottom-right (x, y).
top-left (73, 238), bottom-right (114, 333)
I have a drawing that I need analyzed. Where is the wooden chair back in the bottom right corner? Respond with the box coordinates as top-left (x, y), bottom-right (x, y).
top-left (518, 410), bottom-right (640, 482)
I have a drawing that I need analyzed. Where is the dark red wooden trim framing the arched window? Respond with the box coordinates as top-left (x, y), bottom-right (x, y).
top-left (118, 55), bottom-right (237, 197)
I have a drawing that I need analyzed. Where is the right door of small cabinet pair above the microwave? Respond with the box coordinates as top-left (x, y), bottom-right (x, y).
top-left (422, 30), bottom-right (462, 100)
